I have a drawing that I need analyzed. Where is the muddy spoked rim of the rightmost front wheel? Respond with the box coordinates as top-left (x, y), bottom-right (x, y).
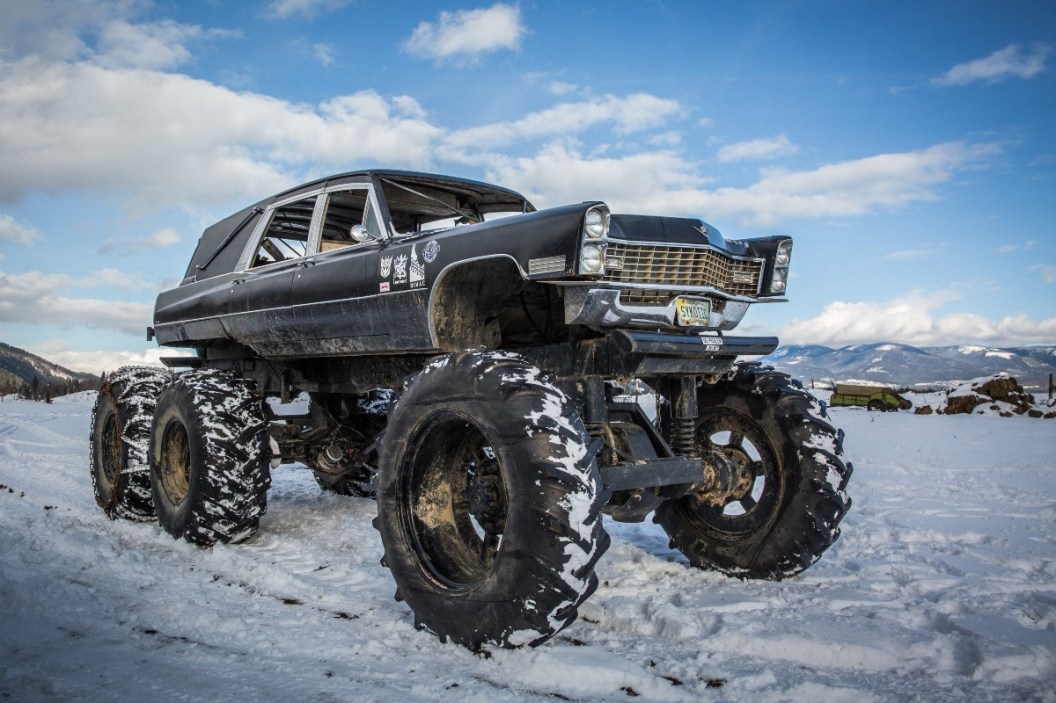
top-left (692, 412), bottom-right (782, 536)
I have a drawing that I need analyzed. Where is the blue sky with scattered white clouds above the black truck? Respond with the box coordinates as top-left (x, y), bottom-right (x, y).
top-left (0, 0), bottom-right (1056, 372)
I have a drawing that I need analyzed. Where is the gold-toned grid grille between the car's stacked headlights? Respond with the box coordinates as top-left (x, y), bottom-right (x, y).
top-left (602, 241), bottom-right (762, 296)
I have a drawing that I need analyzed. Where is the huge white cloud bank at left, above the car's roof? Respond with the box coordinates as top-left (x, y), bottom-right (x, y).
top-left (0, 59), bottom-right (442, 207)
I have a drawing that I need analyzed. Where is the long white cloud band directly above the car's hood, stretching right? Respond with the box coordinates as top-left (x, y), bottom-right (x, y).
top-left (489, 143), bottom-right (998, 222)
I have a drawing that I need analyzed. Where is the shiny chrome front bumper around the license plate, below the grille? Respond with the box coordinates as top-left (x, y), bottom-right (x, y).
top-left (565, 286), bottom-right (751, 331)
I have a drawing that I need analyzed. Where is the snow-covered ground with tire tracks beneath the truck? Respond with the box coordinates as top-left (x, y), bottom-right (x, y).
top-left (0, 394), bottom-right (1056, 703)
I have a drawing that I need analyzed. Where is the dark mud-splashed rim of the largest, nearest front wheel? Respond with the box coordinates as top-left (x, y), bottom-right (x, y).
top-left (399, 413), bottom-right (508, 591)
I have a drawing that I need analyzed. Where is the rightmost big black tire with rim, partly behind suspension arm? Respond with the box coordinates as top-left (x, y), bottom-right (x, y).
top-left (655, 365), bottom-right (852, 580)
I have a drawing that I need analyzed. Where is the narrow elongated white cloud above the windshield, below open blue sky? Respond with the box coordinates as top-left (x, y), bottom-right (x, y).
top-left (444, 93), bottom-right (681, 150)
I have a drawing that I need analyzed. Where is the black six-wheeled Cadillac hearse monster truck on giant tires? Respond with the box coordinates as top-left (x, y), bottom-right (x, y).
top-left (92, 171), bottom-right (851, 647)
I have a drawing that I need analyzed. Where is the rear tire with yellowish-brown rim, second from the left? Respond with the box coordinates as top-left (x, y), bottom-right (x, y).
top-left (150, 369), bottom-right (271, 547)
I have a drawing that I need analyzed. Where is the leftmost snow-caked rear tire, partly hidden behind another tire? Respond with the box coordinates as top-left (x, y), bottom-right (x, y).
top-left (89, 366), bottom-right (172, 521)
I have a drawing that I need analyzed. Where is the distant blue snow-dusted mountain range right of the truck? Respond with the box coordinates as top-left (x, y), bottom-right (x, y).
top-left (761, 343), bottom-right (1056, 387)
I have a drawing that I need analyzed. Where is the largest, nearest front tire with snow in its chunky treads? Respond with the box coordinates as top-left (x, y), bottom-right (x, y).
top-left (375, 353), bottom-right (609, 649)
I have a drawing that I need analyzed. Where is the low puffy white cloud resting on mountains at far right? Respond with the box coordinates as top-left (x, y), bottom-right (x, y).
top-left (780, 290), bottom-right (1056, 346)
